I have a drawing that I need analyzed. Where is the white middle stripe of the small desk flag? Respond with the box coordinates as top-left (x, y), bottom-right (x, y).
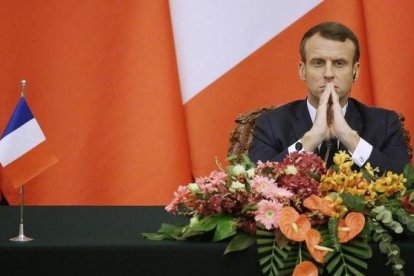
top-left (0, 118), bottom-right (46, 167)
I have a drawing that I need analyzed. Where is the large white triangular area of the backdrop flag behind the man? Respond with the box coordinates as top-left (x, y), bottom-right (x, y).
top-left (170, 0), bottom-right (322, 103)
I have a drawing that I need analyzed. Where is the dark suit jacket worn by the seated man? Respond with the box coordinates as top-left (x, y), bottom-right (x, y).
top-left (249, 98), bottom-right (410, 173)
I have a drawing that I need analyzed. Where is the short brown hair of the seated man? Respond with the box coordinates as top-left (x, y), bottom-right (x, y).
top-left (299, 22), bottom-right (359, 64)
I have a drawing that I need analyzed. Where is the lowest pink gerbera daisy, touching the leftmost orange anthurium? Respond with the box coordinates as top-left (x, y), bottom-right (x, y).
top-left (254, 200), bottom-right (283, 230)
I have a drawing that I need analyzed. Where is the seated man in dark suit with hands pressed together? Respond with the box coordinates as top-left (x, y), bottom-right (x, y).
top-left (249, 22), bottom-right (410, 172)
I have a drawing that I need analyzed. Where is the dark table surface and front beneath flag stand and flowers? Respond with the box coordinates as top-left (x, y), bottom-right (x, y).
top-left (0, 206), bottom-right (414, 276)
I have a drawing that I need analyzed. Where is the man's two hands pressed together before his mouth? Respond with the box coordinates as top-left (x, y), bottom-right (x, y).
top-left (301, 82), bottom-right (360, 153)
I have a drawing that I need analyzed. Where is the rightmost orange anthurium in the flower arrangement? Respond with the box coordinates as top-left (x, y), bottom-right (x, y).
top-left (338, 212), bottom-right (365, 243)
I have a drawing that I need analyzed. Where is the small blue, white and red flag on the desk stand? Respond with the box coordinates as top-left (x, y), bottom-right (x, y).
top-left (0, 97), bottom-right (57, 188)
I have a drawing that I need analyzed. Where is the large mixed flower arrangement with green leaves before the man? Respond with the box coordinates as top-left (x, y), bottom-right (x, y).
top-left (144, 151), bottom-right (414, 275)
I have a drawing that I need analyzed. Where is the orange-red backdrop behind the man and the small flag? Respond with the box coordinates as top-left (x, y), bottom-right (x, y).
top-left (0, 0), bottom-right (414, 205)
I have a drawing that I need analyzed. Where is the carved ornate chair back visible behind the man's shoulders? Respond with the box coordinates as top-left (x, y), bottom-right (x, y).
top-left (228, 106), bottom-right (413, 158)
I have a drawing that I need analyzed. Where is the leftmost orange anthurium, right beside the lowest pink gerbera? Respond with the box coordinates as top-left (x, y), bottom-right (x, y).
top-left (279, 207), bottom-right (311, 242)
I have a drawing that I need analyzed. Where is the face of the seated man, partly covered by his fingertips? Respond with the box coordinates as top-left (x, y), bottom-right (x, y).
top-left (299, 34), bottom-right (360, 108)
